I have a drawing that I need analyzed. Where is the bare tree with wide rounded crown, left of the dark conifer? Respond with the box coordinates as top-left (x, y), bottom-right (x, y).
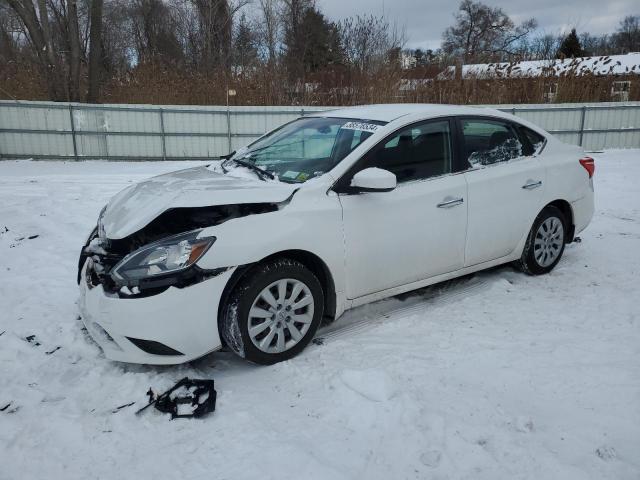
top-left (442, 0), bottom-right (537, 62)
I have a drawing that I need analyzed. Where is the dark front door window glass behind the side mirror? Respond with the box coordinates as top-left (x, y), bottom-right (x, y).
top-left (364, 120), bottom-right (451, 183)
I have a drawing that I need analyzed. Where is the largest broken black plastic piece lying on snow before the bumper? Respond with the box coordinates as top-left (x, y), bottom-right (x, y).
top-left (136, 377), bottom-right (217, 420)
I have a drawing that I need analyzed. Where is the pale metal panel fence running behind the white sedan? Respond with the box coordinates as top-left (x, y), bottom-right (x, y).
top-left (0, 101), bottom-right (640, 160)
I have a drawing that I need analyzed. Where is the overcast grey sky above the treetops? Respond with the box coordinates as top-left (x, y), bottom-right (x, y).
top-left (317, 0), bottom-right (640, 49)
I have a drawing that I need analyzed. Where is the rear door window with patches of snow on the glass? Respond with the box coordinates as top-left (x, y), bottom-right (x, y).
top-left (461, 119), bottom-right (522, 168)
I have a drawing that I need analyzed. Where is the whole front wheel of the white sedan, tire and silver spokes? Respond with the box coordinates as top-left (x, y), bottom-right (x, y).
top-left (220, 258), bottom-right (324, 365)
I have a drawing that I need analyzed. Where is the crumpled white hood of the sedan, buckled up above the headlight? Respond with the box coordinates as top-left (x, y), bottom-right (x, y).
top-left (101, 166), bottom-right (299, 240)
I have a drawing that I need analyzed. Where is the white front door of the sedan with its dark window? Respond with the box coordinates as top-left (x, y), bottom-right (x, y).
top-left (339, 120), bottom-right (467, 299)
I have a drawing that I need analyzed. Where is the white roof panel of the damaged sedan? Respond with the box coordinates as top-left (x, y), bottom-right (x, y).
top-left (313, 103), bottom-right (507, 122)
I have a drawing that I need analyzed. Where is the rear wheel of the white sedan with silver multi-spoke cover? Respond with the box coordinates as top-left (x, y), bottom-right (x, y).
top-left (518, 205), bottom-right (567, 275)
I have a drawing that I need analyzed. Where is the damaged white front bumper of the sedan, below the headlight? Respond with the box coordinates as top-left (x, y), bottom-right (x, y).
top-left (79, 261), bottom-right (235, 365)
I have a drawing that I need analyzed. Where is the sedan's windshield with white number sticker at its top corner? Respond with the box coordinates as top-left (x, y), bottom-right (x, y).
top-left (228, 117), bottom-right (385, 183)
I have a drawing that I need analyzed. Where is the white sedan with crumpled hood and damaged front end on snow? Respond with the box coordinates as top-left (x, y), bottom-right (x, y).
top-left (78, 105), bottom-right (594, 364)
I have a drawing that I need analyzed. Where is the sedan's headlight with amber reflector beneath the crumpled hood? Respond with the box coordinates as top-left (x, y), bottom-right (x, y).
top-left (111, 230), bottom-right (216, 286)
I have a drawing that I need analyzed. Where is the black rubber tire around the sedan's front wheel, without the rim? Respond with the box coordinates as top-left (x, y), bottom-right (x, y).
top-left (220, 258), bottom-right (324, 365)
